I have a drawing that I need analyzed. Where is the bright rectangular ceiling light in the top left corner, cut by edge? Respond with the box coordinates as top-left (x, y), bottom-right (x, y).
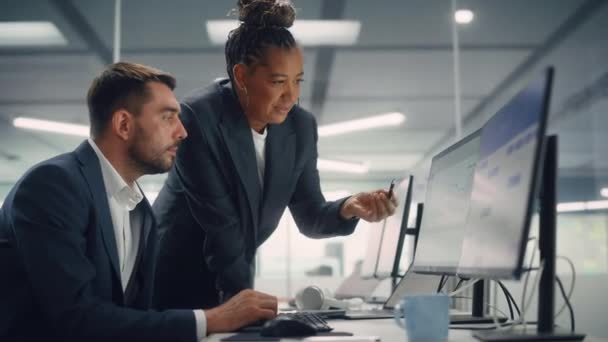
top-left (0, 21), bottom-right (68, 46)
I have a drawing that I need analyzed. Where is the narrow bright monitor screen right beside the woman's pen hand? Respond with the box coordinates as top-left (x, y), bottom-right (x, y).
top-left (376, 176), bottom-right (413, 279)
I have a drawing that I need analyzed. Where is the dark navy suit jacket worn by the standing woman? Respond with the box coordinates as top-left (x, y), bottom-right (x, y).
top-left (154, 80), bottom-right (357, 308)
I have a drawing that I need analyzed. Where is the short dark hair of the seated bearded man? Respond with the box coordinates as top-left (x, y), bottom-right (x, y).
top-left (87, 62), bottom-right (175, 137)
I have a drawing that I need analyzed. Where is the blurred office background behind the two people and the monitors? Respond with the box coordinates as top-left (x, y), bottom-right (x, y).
top-left (0, 0), bottom-right (608, 337)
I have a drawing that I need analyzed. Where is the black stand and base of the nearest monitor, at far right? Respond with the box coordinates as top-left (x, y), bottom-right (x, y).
top-left (473, 135), bottom-right (585, 341)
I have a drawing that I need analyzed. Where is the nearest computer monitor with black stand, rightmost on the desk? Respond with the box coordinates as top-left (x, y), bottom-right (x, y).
top-left (458, 67), bottom-right (585, 341)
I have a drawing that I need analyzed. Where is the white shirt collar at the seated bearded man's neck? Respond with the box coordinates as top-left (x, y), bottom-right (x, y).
top-left (87, 138), bottom-right (144, 211)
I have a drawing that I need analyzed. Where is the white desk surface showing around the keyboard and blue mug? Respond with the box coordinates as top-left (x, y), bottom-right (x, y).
top-left (207, 319), bottom-right (608, 342)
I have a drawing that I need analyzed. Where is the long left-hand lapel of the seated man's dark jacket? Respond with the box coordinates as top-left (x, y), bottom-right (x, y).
top-left (76, 142), bottom-right (120, 279)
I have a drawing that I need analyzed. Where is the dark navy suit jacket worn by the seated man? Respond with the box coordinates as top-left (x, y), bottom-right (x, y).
top-left (0, 142), bottom-right (196, 342)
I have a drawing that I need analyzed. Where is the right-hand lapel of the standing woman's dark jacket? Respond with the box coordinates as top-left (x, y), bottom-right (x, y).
top-left (262, 118), bottom-right (296, 216)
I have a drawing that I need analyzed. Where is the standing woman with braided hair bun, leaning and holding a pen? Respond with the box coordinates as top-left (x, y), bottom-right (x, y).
top-left (154, 0), bottom-right (396, 308)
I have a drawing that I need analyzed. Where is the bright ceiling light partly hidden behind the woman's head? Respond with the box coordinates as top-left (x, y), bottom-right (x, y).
top-left (206, 20), bottom-right (361, 46)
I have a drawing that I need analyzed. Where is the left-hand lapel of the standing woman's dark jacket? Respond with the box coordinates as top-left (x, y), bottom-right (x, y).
top-left (219, 94), bottom-right (262, 230)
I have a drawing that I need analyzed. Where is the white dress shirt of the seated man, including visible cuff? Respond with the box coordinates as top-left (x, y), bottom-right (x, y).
top-left (88, 138), bottom-right (207, 340)
